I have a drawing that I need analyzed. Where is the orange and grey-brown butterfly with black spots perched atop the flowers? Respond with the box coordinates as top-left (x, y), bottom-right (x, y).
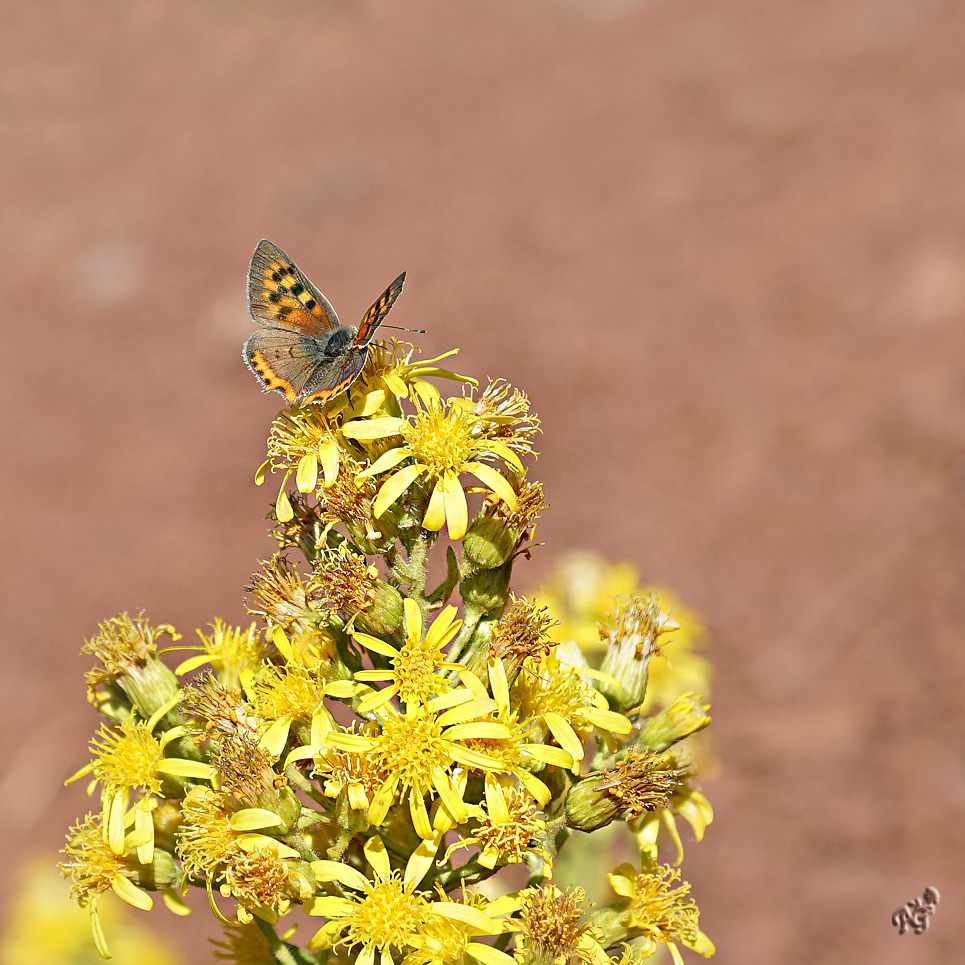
top-left (243, 241), bottom-right (421, 405)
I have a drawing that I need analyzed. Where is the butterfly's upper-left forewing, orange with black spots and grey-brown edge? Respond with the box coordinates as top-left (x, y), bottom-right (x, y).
top-left (248, 241), bottom-right (339, 335)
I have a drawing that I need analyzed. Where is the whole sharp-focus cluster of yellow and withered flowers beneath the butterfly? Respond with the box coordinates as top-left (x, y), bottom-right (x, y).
top-left (62, 342), bottom-right (713, 965)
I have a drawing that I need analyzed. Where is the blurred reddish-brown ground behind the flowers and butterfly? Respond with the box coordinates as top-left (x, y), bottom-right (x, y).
top-left (0, 0), bottom-right (965, 965)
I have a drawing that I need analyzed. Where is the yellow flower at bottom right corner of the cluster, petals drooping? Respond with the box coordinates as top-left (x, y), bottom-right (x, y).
top-left (608, 864), bottom-right (716, 965)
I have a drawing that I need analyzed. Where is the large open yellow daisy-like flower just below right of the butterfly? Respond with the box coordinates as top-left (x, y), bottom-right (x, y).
top-left (343, 398), bottom-right (523, 539)
